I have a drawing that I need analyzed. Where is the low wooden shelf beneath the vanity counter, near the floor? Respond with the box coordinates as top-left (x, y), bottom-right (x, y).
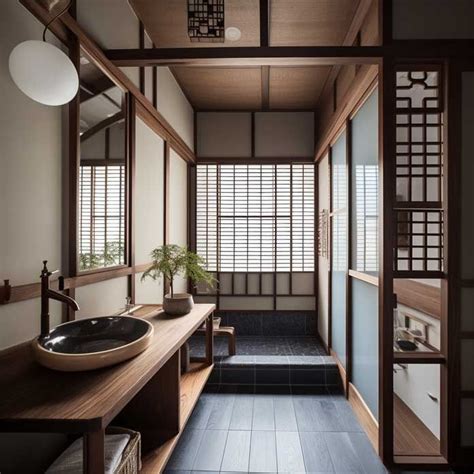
top-left (141, 363), bottom-right (214, 474)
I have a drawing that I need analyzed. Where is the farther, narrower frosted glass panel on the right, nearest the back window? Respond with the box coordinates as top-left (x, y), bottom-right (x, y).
top-left (331, 131), bottom-right (348, 366)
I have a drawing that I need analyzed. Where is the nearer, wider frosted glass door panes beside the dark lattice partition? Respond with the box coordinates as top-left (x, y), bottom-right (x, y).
top-left (350, 90), bottom-right (379, 417)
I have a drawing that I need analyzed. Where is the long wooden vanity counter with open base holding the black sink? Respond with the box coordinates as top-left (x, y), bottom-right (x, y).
top-left (0, 304), bottom-right (215, 473)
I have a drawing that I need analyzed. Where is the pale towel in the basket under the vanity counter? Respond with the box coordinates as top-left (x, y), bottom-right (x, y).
top-left (46, 434), bottom-right (130, 474)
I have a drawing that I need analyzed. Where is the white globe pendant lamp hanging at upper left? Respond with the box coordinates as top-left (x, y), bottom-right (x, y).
top-left (8, 2), bottom-right (79, 106)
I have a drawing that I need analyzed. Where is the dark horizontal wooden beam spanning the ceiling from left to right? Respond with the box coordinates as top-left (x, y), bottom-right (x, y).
top-left (104, 46), bottom-right (384, 67)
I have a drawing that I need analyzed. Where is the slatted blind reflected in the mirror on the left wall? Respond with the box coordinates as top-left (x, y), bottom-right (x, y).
top-left (79, 165), bottom-right (125, 270)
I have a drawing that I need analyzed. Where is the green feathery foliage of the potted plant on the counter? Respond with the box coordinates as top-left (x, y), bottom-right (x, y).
top-left (141, 245), bottom-right (216, 297)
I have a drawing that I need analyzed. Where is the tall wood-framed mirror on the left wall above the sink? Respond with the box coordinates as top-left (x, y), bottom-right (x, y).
top-left (77, 51), bottom-right (128, 272)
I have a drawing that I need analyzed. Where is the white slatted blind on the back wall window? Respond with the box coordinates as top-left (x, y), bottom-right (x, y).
top-left (196, 164), bottom-right (315, 272)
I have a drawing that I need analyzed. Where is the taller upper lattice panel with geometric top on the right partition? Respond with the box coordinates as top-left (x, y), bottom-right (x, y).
top-left (396, 70), bottom-right (443, 208)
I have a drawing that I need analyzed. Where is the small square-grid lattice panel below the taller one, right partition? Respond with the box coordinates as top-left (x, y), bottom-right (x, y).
top-left (395, 209), bottom-right (443, 272)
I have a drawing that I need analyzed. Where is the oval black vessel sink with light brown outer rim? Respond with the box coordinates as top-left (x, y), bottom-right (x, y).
top-left (33, 316), bottom-right (153, 371)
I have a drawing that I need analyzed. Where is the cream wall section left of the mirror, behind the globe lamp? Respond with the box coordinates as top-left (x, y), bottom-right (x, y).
top-left (0, 0), bottom-right (62, 349)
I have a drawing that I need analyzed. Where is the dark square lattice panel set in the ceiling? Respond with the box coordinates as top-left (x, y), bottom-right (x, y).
top-left (188, 0), bottom-right (225, 43)
